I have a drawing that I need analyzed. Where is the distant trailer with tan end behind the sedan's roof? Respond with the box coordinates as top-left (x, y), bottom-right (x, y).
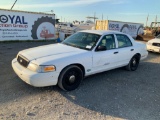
top-left (95, 20), bottom-right (144, 38)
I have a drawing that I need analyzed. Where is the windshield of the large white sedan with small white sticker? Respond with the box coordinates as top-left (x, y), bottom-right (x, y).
top-left (62, 32), bottom-right (101, 50)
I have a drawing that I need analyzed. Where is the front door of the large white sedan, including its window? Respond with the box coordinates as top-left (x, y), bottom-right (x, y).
top-left (92, 34), bottom-right (118, 73)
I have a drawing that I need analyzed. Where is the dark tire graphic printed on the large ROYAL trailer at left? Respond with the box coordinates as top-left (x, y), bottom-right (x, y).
top-left (31, 16), bottom-right (55, 39)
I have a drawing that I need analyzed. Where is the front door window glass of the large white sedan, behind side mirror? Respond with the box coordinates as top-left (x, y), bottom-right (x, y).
top-left (99, 34), bottom-right (116, 50)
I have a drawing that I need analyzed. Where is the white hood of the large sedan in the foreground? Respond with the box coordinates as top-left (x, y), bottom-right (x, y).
top-left (19, 43), bottom-right (86, 61)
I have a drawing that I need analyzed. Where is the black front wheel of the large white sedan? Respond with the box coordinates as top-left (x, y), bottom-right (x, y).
top-left (58, 65), bottom-right (83, 91)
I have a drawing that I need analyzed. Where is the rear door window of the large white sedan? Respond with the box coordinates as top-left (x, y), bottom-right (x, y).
top-left (116, 34), bottom-right (132, 48)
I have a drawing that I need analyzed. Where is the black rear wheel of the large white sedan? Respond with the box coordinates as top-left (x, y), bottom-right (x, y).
top-left (126, 55), bottom-right (140, 71)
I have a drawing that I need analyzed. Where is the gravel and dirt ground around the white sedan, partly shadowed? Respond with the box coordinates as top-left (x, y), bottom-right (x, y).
top-left (0, 42), bottom-right (160, 120)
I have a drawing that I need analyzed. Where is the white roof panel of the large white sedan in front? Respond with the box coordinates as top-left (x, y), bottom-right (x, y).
top-left (79, 30), bottom-right (124, 35)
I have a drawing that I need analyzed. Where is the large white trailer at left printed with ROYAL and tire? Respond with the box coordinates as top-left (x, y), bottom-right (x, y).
top-left (0, 9), bottom-right (56, 41)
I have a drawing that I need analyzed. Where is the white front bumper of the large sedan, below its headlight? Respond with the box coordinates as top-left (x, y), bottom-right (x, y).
top-left (12, 58), bottom-right (59, 87)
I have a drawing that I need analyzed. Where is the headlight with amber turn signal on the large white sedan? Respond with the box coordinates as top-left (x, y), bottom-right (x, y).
top-left (28, 62), bottom-right (56, 73)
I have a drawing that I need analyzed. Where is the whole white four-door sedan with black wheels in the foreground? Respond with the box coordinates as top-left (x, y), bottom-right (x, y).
top-left (12, 30), bottom-right (148, 91)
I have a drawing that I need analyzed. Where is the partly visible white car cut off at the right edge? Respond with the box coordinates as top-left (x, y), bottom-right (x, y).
top-left (147, 35), bottom-right (160, 53)
